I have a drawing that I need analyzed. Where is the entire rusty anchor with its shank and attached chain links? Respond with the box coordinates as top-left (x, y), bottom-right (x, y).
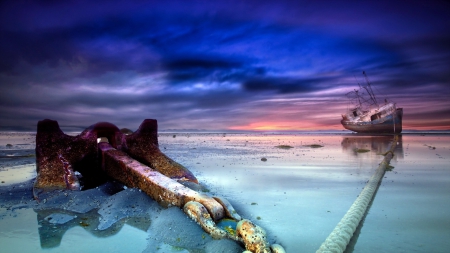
top-left (33, 119), bottom-right (285, 253)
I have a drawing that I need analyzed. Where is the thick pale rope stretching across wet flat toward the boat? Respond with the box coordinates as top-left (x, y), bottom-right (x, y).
top-left (316, 135), bottom-right (398, 253)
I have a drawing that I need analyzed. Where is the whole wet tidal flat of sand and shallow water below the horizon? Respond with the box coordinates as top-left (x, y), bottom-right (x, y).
top-left (0, 133), bottom-right (450, 252)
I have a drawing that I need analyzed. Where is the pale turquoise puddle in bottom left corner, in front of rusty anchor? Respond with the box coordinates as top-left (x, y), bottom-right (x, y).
top-left (0, 209), bottom-right (147, 253)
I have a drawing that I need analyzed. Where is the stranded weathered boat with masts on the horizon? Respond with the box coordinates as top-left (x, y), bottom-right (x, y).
top-left (341, 71), bottom-right (403, 134)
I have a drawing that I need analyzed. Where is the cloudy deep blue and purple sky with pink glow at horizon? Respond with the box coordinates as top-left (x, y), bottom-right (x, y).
top-left (0, 0), bottom-right (450, 131)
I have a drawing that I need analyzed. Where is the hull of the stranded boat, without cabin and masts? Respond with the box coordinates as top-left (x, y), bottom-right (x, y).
top-left (341, 108), bottom-right (403, 134)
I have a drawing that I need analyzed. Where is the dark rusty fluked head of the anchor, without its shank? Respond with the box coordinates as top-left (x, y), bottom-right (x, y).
top-left (34, 119), bottom-right (198, 199)
